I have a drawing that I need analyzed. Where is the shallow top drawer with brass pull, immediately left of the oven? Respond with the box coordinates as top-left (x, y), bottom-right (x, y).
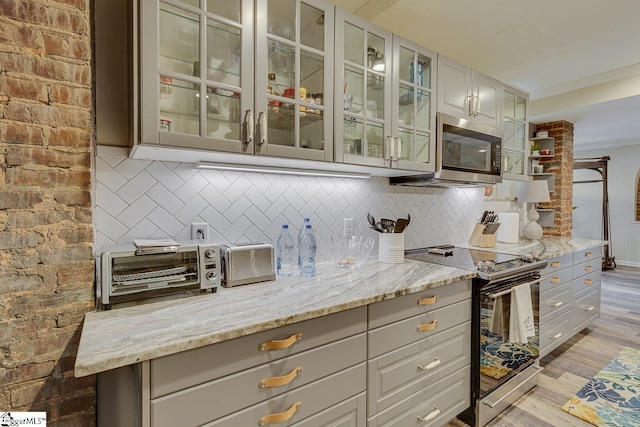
top-left (369, 280), bottom-right (471, 329)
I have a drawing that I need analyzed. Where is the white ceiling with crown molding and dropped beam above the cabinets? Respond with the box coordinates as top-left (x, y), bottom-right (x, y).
top-left (332, 0), bottom-right (640, 150)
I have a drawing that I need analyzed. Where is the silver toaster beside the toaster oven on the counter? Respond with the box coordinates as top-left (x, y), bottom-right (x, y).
top-left (220, 243), bottom-right (276, 288)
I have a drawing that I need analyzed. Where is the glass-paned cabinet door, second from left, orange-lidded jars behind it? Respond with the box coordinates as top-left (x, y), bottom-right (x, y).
top-left (255, 0), bottom-right (334, 161)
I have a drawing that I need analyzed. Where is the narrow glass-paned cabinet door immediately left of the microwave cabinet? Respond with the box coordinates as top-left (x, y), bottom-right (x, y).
top-left (390, 35), bottom-right (437, 172)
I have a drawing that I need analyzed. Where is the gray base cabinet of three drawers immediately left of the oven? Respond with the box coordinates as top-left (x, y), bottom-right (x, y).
top-left (367, 280), bottom-right (471, 427)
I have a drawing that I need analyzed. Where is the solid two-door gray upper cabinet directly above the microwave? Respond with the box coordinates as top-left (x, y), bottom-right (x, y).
top-left (438, 54), bottom-right (503, 128)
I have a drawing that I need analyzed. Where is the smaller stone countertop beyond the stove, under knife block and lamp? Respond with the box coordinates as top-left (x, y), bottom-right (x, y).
top-left (457, 237), bottom-right (607, 259)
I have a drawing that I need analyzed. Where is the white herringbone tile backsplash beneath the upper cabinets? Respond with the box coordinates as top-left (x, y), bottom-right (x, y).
top-left (96, 157), bottom-right (508, 261)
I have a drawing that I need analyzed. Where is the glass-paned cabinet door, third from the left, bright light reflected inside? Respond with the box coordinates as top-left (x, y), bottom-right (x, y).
top-left (333, 8), bottom-right (394, 167)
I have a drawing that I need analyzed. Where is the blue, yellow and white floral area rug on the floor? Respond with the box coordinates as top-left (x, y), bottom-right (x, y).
top-left (562, 347), bottom-right (640, 427)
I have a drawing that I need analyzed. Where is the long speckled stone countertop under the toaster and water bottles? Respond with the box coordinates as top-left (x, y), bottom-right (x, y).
top-left (75, 260), bottom-right (475, 377)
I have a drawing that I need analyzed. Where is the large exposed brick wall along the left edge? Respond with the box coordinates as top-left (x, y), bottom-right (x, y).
top-left (0, 0), bottom-right (95, 427)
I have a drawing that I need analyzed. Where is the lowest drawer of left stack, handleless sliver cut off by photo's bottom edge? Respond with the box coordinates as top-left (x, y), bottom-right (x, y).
top-left (291, 393), bottom-right (367, 427)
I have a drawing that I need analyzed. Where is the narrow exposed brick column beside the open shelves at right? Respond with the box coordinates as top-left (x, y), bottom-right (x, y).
top-left (536, 120), bottom-right (573, 237)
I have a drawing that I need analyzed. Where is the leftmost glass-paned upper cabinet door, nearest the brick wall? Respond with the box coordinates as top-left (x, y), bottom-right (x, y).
top-left (140, 0), bottom-right (254, 154)
